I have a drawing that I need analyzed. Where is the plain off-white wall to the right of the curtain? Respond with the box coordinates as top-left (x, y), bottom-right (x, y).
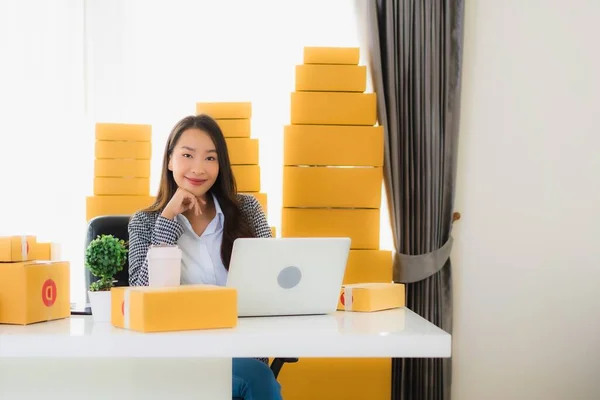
top-left (452, 0), bottom-right (600, 400)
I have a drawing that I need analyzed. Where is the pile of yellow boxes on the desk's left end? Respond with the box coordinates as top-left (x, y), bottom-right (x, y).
top-left (0, 236), bottom-right (71, 325)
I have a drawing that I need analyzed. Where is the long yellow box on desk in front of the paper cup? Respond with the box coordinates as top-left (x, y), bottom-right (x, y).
top-left (111, 285), bottom-right (237, 332)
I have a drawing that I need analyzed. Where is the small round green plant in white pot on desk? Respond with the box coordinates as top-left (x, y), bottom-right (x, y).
top-left (85, 235), bottom-right (128, 322)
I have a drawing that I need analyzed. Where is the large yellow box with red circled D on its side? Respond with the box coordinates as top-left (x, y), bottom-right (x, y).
top-left (0, 261), bottom-right (71, 325)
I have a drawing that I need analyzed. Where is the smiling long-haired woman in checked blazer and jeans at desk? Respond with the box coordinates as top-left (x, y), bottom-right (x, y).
top-left (128, 114), bottom-right (281, 400)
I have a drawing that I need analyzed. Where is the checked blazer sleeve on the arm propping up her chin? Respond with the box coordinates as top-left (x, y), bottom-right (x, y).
top-left (128, 212), bottom-right (183, 286)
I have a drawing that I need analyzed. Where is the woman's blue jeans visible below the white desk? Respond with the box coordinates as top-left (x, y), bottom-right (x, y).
top-left (232, 358), bottom-right (282, 400)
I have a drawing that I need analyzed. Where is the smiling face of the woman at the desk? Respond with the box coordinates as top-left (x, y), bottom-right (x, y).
top-left (169, 128), bottom-right (219, 197)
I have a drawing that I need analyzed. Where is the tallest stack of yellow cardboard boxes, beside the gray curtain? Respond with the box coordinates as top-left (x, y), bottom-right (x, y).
top-left (281, 47), bottom-right (392, 400)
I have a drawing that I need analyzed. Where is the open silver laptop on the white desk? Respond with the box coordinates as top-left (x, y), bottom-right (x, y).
top-left (226, 238), bottom-right (350, 317)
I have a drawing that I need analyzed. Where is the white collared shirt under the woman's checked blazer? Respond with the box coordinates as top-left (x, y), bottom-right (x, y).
top-left (177, 195), bottom-right (227, 286)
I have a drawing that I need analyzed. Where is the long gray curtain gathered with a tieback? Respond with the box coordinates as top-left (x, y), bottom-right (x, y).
top-left (357, 0), bottom-right (464, 400)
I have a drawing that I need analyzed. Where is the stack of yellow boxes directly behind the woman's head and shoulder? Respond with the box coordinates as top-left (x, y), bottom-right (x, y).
top-left (196, 102), bottom-right (275, 236)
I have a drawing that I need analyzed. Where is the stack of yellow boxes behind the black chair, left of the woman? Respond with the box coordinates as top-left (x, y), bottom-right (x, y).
top-left (86, 123), bottom-right (155, 222)
